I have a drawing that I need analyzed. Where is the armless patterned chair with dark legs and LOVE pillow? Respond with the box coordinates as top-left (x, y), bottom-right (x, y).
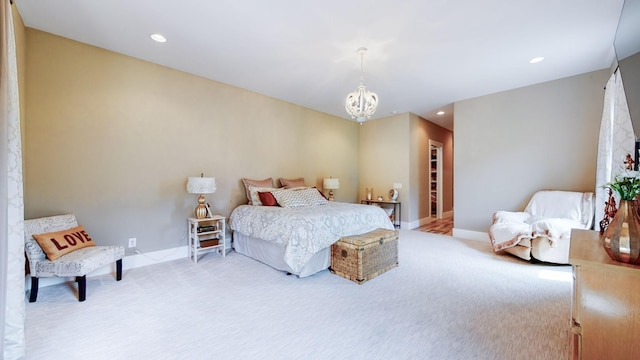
top-left (24, 214), bottom-right (124, 302)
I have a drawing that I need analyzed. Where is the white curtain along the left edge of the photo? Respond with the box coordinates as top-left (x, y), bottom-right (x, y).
top-left (0, 0), bottom-right (26, 359)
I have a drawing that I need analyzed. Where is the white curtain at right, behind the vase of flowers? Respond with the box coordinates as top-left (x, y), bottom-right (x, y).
top-left (595, 71), bottom-right (636, 230)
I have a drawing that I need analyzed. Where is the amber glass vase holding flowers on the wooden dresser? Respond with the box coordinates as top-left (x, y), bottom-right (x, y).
top-left (600, 200), bottom-right (640, 264)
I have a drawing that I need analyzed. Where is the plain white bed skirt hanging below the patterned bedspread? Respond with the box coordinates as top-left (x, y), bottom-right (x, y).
top-left (233, 231), bottom-right (331, 277)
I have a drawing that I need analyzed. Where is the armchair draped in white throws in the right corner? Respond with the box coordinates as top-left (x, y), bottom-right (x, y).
top-left (489, 190), bottom-right (594, 264)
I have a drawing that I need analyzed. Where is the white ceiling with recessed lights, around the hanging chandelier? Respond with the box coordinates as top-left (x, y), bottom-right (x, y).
top-left (15, 0), bottom-right (623, 129)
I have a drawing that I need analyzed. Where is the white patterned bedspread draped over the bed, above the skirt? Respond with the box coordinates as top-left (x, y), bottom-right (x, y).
top-left (229, 202), bottom-right (393, 272)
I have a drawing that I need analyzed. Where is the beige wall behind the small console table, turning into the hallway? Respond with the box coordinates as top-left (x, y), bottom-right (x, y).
top-left (359, 113), bottom-right (453, 228)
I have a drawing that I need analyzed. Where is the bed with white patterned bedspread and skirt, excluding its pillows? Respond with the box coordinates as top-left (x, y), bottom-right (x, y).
top-left (229, 202), bottom-right (394, 277)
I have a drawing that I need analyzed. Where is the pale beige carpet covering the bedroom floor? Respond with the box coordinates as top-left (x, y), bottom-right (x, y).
top-left (26, 230), bottom-right (571, 360)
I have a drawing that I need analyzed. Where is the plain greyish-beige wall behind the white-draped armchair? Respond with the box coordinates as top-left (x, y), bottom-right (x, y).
top-left (454, 69), bottom-right (609, 235)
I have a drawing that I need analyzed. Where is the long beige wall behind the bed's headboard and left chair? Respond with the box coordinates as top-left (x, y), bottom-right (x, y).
top-left (24, 28), bottom-right (360, 253)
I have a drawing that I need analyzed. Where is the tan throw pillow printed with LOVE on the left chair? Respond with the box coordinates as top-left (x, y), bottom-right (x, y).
top-left (33, 226), bottom-right (96, 261)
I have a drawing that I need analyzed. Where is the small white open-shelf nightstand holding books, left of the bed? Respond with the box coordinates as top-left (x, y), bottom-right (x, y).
top-left (187, 215), bottom-right (226, 264)
